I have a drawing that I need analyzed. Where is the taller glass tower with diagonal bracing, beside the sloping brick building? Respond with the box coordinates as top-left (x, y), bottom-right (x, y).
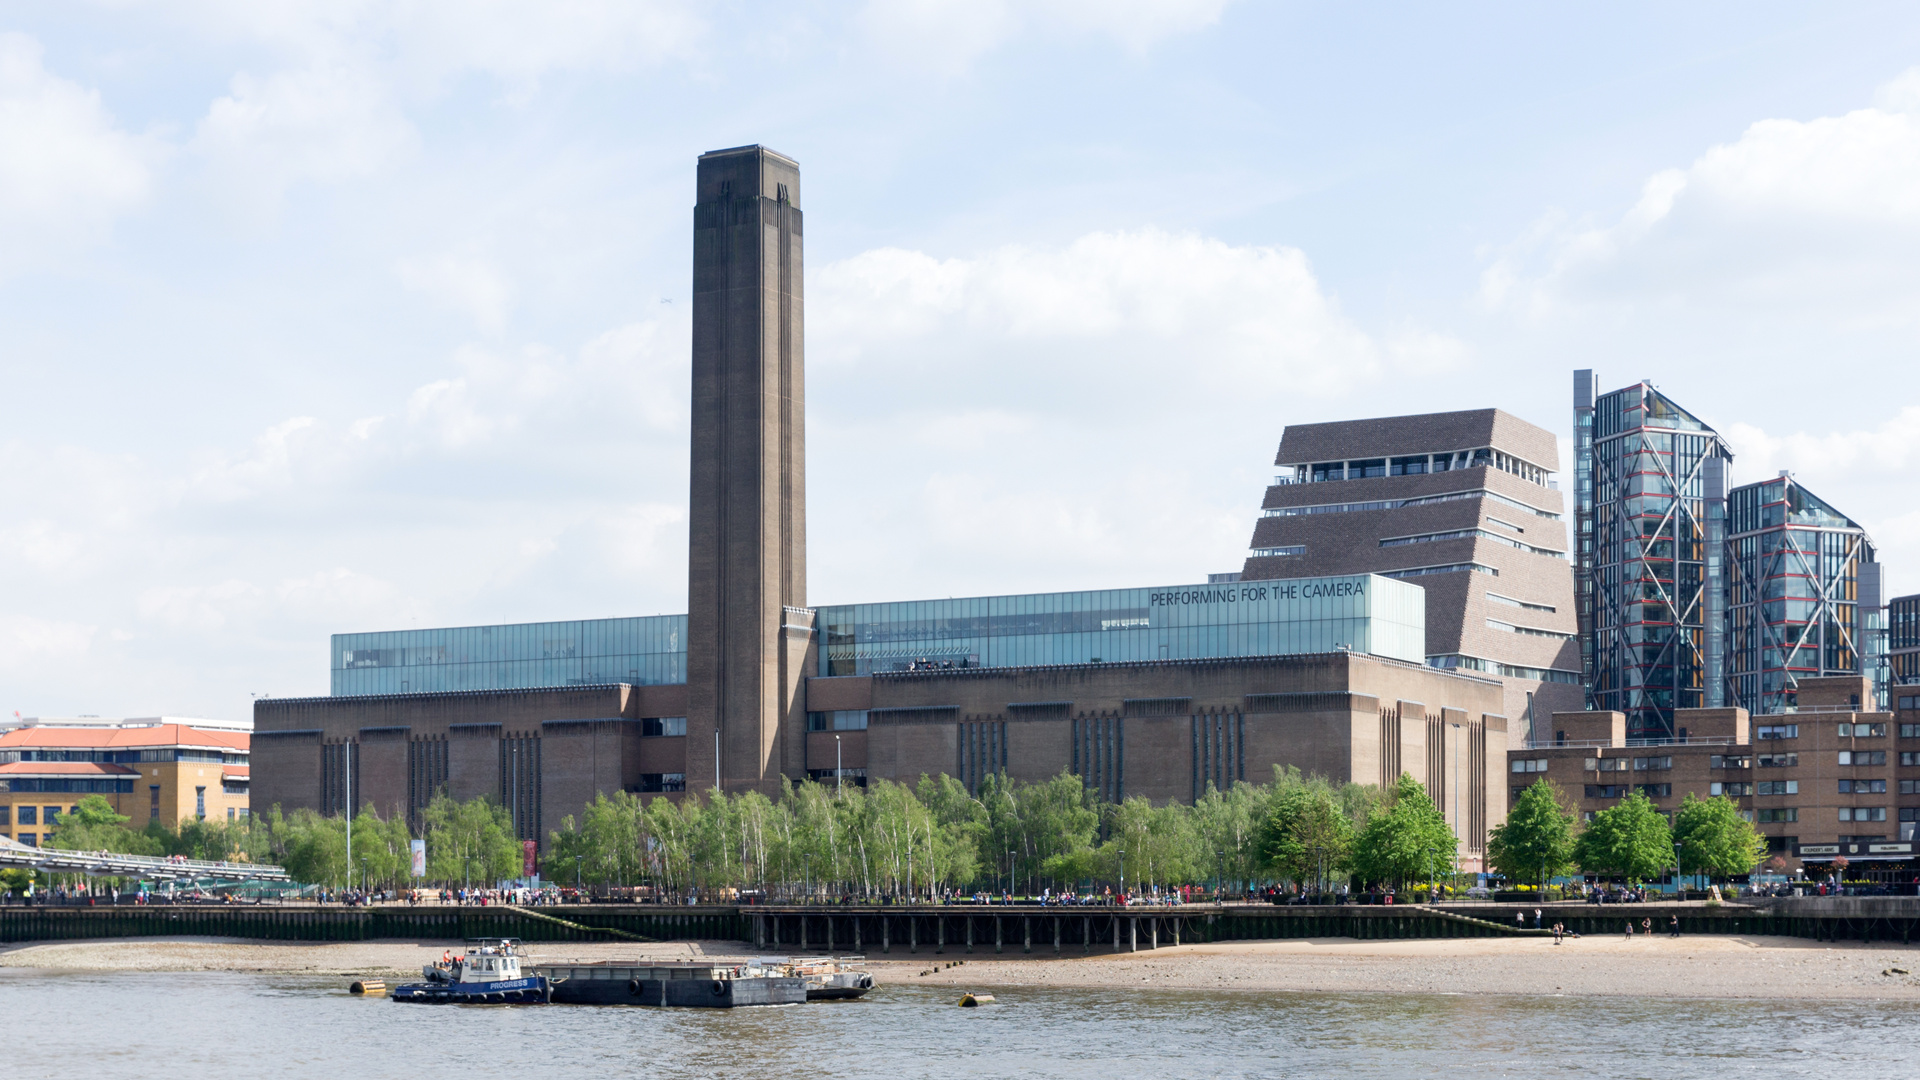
top-left (1572, 369), bottom-right (1734, 740)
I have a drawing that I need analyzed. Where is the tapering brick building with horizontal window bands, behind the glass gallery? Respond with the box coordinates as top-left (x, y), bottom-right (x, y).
top-left (1240, 409), bottom-right (1582, 740)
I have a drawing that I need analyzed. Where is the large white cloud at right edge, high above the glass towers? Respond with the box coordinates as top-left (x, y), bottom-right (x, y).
top-left (1480, 69), bottom-right (1920, 319)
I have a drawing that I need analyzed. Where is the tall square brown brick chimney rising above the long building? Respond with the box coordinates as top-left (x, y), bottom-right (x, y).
top-left (687, 146), bottom-right (812, 790)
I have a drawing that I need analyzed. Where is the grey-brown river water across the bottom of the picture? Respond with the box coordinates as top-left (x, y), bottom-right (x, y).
top-left (0, 970), bottom-right (1920, 1080)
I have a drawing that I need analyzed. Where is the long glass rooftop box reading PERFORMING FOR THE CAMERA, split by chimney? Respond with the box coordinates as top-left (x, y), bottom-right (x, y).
top-left (332, 575), bottom-right (1427, 698)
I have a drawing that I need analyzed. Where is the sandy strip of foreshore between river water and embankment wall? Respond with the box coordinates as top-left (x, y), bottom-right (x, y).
top-left (0, 934), bottom-right (1920, 1001)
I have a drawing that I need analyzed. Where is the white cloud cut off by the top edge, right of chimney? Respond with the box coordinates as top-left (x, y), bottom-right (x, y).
top-left (862, 0), bottom-right (1233, 75)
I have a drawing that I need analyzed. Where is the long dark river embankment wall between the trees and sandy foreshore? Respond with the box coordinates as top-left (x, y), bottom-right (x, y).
top-left (0, 897), bottom-right (1920, 955)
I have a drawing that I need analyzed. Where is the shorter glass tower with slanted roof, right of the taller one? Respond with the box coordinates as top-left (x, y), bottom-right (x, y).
top-left (1726, 473), bottom-right (1885, 715)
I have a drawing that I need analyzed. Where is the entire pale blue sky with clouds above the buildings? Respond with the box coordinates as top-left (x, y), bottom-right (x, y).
top-left (0, 0), bottom-right (1920, 717)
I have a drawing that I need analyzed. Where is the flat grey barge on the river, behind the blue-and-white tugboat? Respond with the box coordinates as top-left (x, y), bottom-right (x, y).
top-left (534, 961), bottom-right (808, 1009)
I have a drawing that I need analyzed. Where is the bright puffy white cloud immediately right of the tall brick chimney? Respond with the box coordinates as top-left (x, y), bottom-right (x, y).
top-left (810, 223), bottom-right (1382, 409)
